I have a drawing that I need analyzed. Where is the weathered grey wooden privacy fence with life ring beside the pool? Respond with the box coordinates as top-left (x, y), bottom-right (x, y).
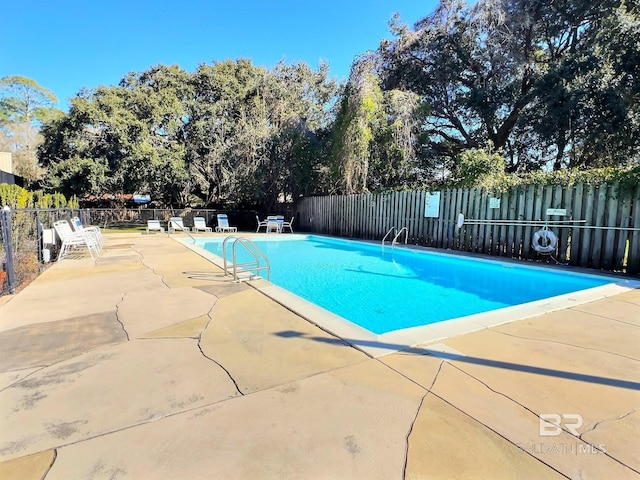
top-left (297, 182), bottom-right (640, 274)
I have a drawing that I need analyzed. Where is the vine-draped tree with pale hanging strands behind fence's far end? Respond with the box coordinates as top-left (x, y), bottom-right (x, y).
top-left (331, 54), bottom-right (428, 194)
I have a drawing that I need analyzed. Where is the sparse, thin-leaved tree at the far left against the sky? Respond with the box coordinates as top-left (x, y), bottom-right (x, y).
top-left (0, 75), bottom-right (62, 183)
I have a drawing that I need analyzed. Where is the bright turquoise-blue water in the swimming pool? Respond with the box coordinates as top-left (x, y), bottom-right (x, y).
top-left (197, 235), bottom-right (613, 334)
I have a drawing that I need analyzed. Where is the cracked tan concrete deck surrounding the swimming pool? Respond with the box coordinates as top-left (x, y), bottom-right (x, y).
top-left (0, 234), bottom-right (640, 480)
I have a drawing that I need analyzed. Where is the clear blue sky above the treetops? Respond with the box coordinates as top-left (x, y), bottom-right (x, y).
top-left (0, 0), bottom-right (438, 109)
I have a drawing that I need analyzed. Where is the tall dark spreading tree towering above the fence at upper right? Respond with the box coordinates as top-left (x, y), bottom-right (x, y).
top-left (378, 0), bottom-right (640, 175)
